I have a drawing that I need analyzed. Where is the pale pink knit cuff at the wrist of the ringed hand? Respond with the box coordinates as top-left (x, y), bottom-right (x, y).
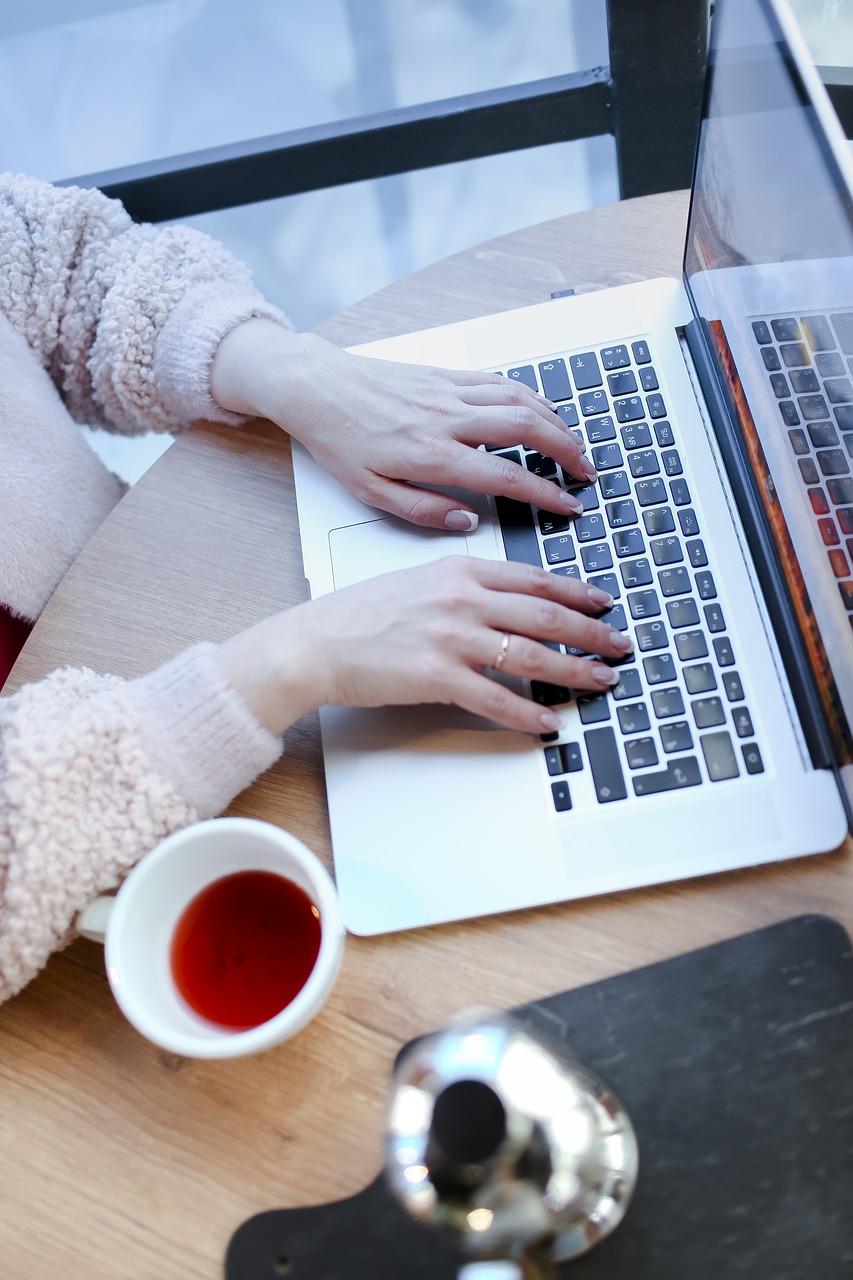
top-left (124, 644), bottom-right (282, 818)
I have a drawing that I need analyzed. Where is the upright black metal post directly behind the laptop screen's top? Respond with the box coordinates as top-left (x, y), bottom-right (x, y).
top-left (607, 0), bottom-right (710, 200)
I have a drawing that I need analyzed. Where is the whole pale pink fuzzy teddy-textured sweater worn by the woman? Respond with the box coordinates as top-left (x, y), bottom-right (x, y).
top-left (0, 174), bottom-right (287, 1000)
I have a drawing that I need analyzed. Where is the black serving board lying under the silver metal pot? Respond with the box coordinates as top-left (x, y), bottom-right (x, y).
top-left (225, 915), bottom-right (853, 1280)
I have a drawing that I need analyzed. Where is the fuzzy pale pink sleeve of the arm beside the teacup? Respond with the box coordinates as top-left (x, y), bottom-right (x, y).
top-left (0, 644), bottom-right (282, 1000)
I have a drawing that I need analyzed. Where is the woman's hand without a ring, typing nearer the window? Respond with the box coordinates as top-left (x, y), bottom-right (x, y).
top-left (211, 320), bottom-right (596, 531)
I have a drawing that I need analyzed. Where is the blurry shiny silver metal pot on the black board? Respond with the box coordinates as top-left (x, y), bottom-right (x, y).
top-left (386, 1014), bottom-right (638, 1277)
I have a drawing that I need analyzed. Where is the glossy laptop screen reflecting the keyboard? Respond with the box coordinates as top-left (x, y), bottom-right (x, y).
top-left (684, 0), bottom-right (853, 764)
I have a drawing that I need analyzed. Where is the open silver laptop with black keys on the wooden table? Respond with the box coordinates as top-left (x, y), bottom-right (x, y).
top-left (293, 0), bottom-right (853, 934)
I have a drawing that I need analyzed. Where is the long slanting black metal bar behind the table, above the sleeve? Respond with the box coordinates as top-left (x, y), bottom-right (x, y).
top-left (60, 72), bottom-right (612, 221)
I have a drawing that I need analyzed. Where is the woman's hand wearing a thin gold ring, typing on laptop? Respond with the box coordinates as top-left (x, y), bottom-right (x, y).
top-left (219, 556), bottom-right (633, 733)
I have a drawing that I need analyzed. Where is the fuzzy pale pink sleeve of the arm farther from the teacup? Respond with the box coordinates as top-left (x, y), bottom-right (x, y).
top-left (0, 173), bottom-right (289, 435)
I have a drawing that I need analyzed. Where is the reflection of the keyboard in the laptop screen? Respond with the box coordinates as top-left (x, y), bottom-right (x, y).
top-left (752, 311), bottom-right (853, 626)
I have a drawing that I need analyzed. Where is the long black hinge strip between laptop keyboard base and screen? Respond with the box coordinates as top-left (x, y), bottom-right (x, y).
top-left (684, 317), bottom-right (836, 769)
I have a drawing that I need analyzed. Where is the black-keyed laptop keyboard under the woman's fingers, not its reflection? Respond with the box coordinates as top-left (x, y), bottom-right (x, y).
top-left (492, 339), bottom-right (765, 812)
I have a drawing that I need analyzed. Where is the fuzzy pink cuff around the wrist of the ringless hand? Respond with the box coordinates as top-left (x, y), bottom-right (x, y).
top-left (154, 284), bottom-right (293, 426)
